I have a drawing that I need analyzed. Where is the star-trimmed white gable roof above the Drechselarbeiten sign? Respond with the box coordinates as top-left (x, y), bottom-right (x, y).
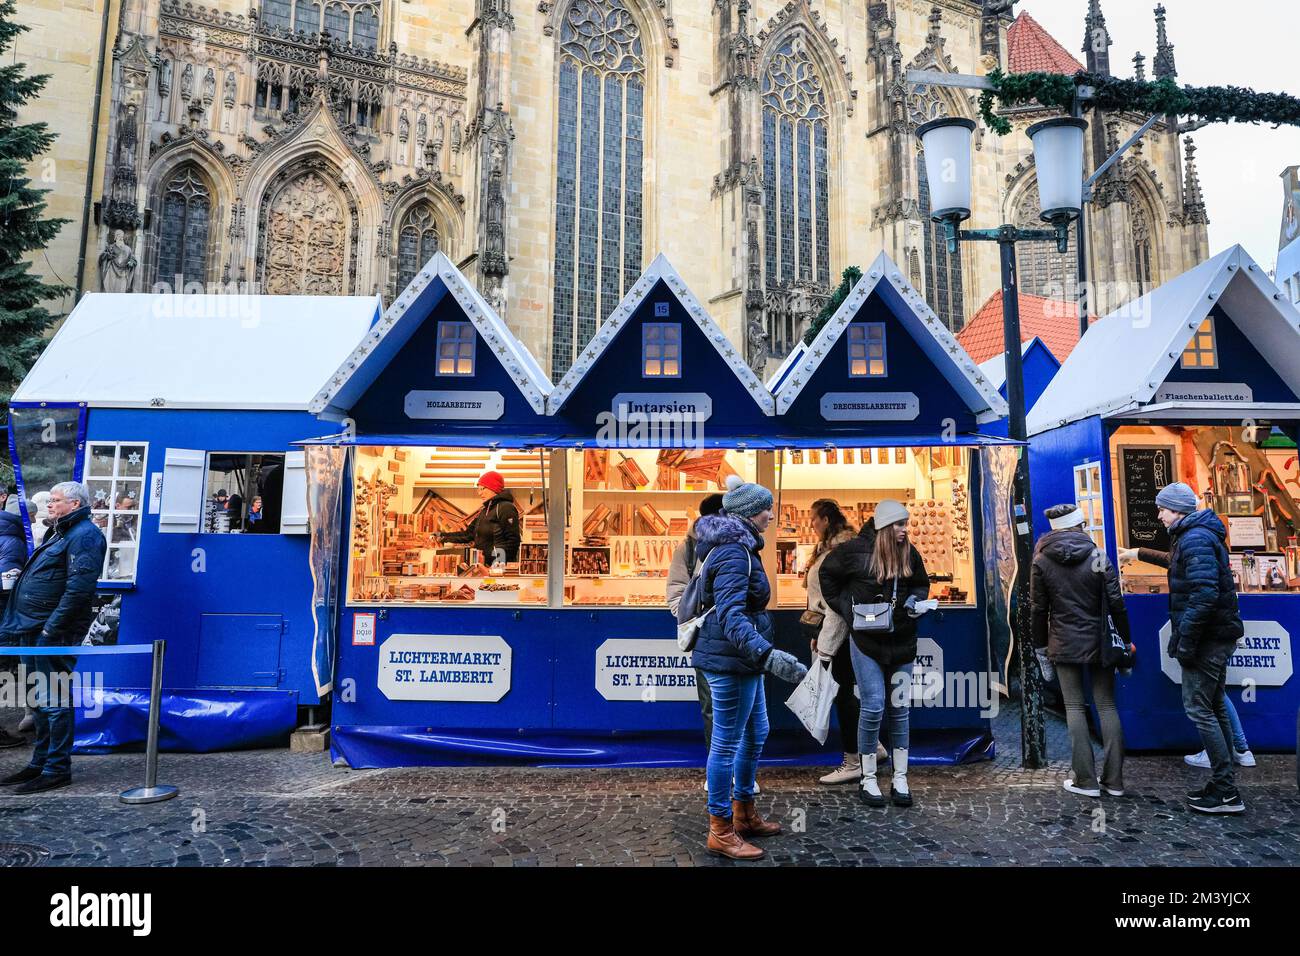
top-left (776, 252), bottom-right (1006, 423)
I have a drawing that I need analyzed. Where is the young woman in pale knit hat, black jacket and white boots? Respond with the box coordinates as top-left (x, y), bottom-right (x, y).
top-left (819, 498), bottom-right (930, 806)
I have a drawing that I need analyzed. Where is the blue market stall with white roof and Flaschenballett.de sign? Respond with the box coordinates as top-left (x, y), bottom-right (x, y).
top-left (1028, 246), bottom-right (1300, 752)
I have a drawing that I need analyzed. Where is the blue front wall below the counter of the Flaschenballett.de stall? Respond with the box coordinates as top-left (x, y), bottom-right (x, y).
top-left (1115, 594), bottom-right (1300, 753)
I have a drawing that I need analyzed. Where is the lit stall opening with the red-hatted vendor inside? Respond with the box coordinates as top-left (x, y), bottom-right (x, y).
top-left (347, 446), bottom-right (550, 606)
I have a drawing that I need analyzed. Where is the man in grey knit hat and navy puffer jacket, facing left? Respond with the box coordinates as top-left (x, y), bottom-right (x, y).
top-left (1121, 481), bottom-right (1245, 813)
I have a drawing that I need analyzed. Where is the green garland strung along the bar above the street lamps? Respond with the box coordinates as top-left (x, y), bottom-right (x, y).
top-left (979, 69), bottom-right (1300, 137)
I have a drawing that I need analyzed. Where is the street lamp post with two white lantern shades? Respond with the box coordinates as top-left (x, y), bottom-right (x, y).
top-left (917, 116), bottom-right (1088, 769)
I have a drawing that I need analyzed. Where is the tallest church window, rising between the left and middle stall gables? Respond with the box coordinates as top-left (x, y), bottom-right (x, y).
top-left (551, 0), bottom-right (646, 377)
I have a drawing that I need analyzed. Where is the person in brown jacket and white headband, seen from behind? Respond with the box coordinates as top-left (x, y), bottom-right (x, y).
top-left (1030, 505), bottom-right (1128, 797)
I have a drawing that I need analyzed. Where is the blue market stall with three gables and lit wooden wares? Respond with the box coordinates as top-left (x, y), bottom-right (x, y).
top-left (304, 255), bottom-right (1010, 766)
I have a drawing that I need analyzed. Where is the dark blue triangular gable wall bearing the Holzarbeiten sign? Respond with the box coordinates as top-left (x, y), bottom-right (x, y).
top-left (345, 295), bottom-right (554, 440)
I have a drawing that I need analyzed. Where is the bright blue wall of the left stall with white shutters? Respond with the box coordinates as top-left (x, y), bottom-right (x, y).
top-left (86, 408), bottom-right (321, 705)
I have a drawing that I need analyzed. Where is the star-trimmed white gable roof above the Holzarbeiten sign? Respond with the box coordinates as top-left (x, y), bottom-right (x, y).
top-left (311, 252), bottom-right (553, 421)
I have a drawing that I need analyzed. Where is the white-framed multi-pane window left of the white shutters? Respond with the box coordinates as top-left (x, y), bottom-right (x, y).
top-left (85, 441), bottom-right (150, 581)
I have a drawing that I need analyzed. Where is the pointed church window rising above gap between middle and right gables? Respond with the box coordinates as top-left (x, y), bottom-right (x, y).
top-left (762, 33), bottom-right (831, 299)
